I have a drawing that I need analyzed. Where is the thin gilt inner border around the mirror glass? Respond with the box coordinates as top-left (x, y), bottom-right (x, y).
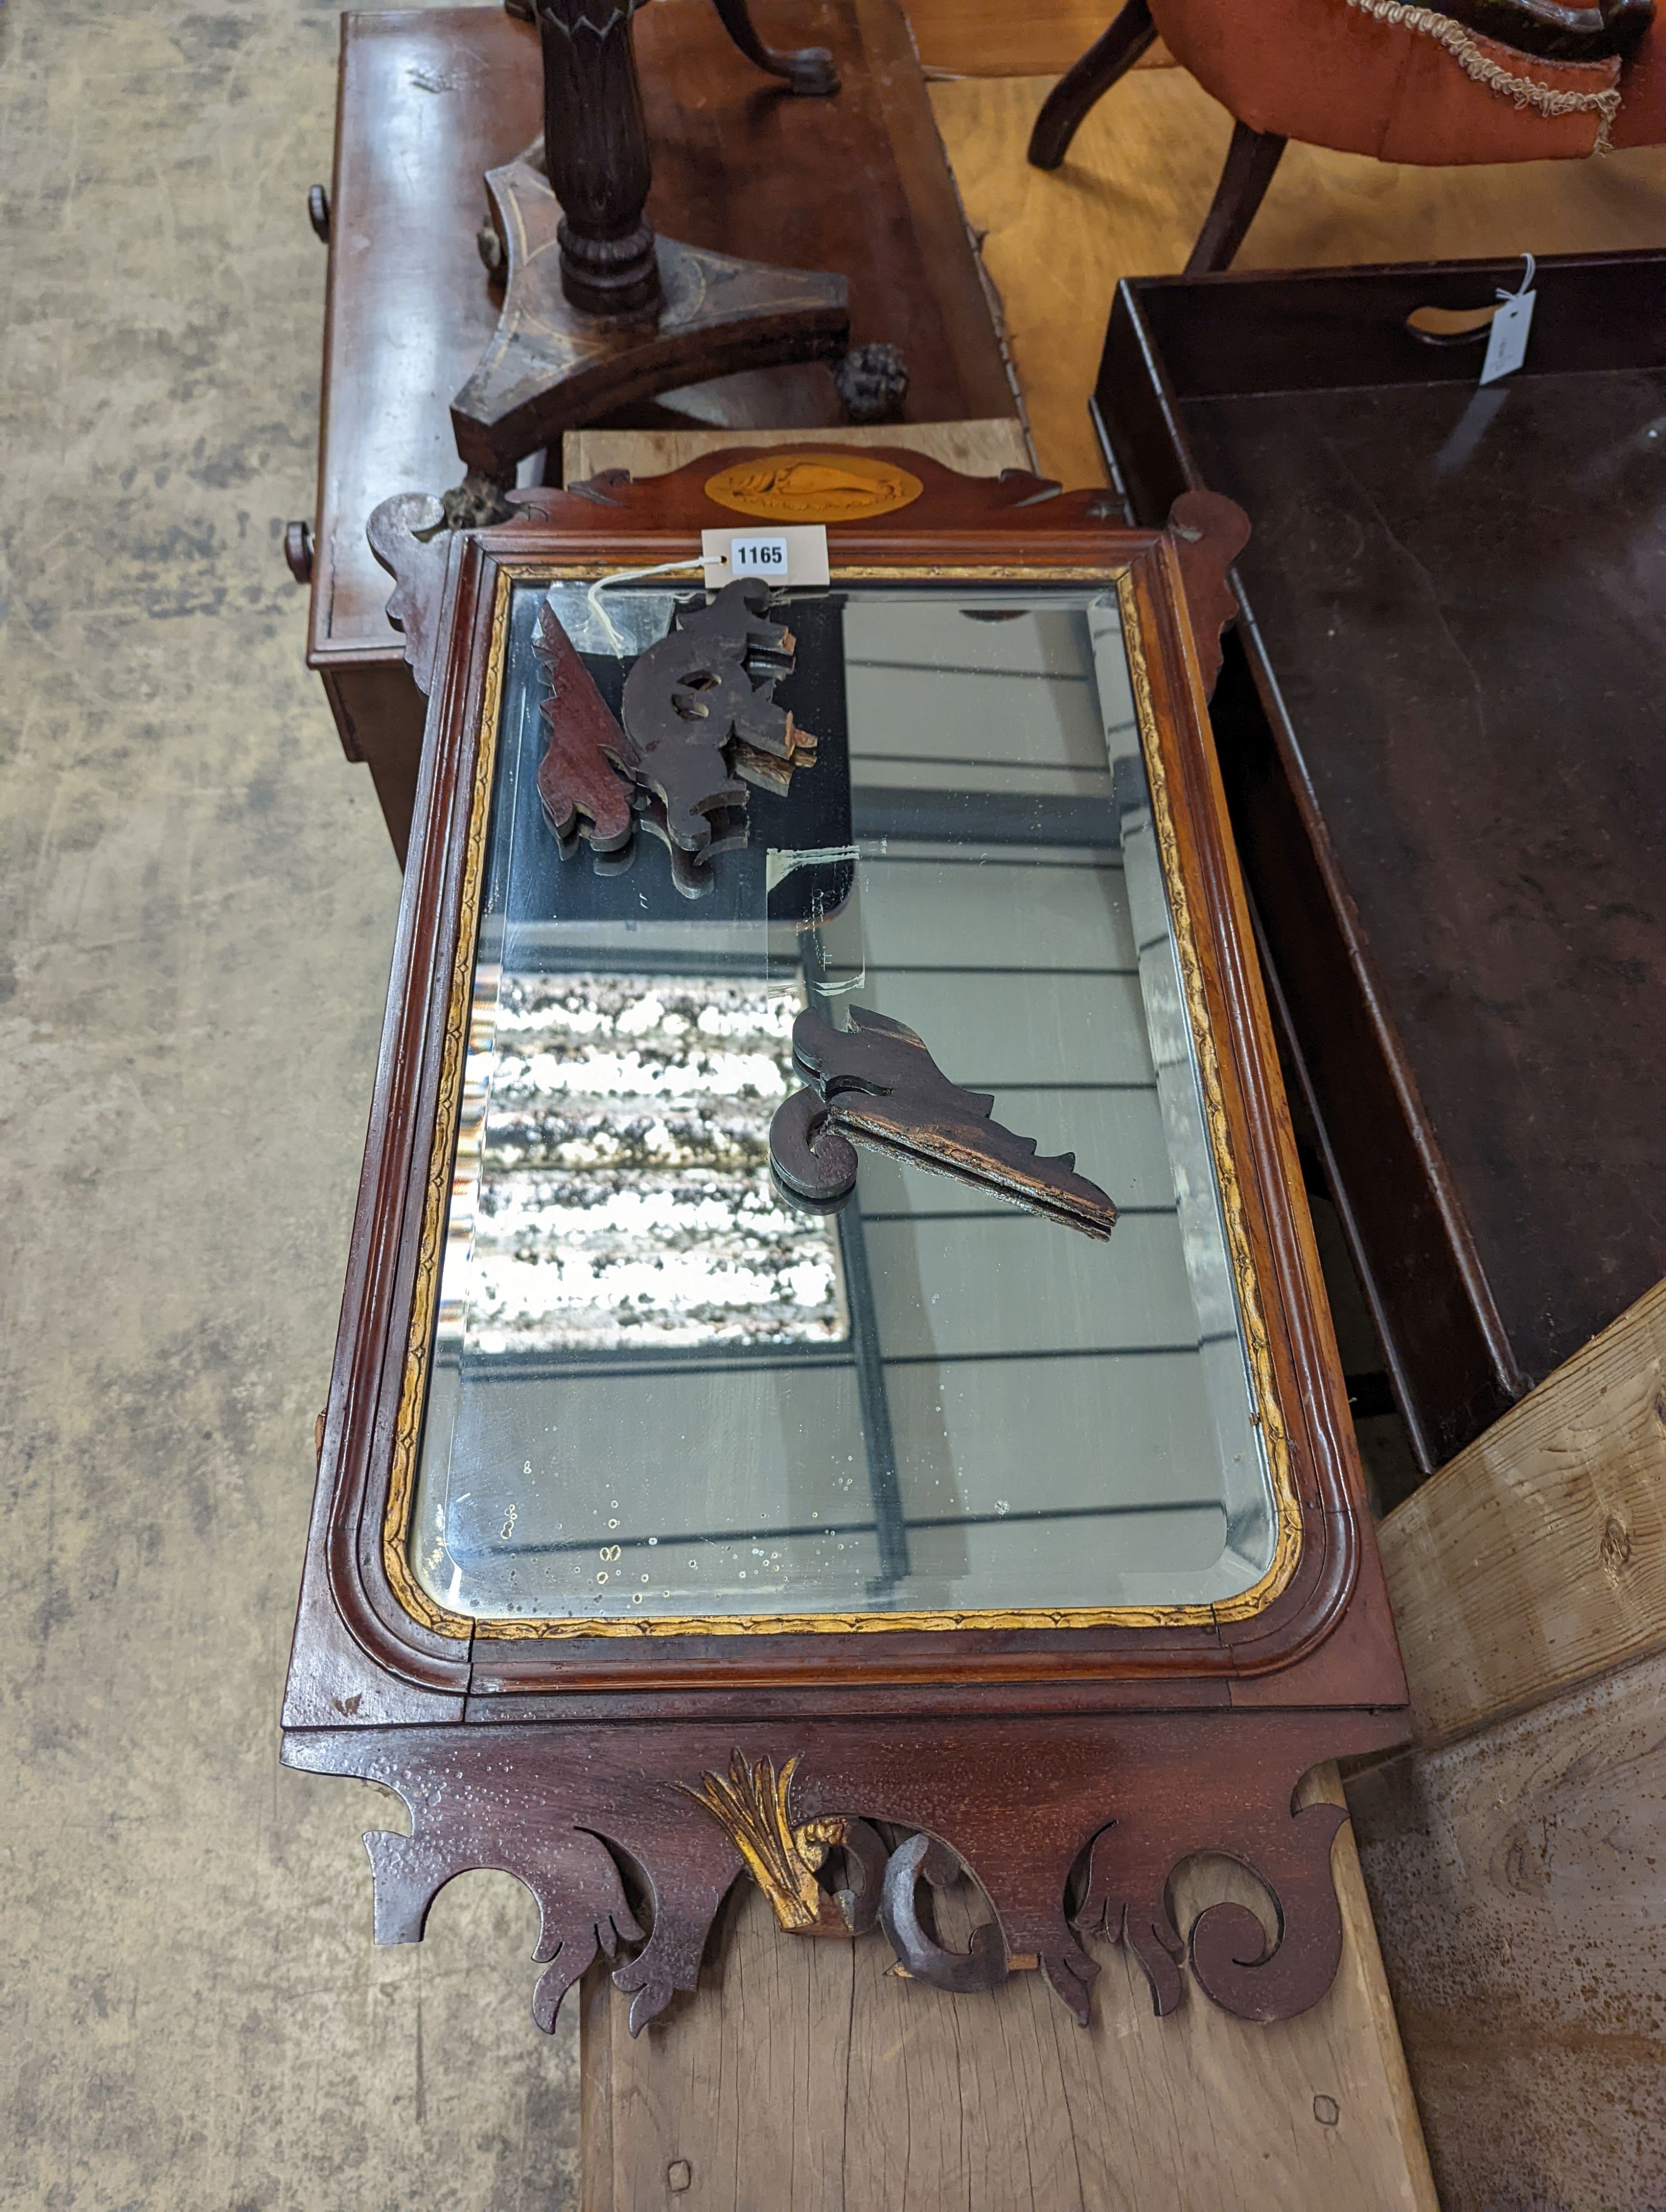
top-left (380, 557), bottom-right (1303, 1641)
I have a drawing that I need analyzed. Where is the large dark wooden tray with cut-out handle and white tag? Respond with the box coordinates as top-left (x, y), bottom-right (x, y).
top-left (1093, 252), bottom-right (1666, 1469)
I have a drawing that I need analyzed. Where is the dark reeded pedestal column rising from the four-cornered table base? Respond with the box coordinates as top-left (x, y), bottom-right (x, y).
top-left (538, 0), bottom-right (659, 314)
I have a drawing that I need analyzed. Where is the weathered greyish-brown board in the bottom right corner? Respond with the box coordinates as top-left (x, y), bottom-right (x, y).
top-left (1347, 1652), bottom-right (1666, 2212)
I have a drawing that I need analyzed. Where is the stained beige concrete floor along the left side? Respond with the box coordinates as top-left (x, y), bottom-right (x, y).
top-left (0, 0), bottom-right (578, 2212)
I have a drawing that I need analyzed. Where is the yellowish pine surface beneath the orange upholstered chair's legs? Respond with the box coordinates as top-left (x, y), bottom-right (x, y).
top-left (916, 73), bottom-right (1666, 489)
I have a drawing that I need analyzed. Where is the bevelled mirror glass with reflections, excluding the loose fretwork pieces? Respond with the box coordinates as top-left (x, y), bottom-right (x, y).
top-left (412, 582), bottom-right (1274, 1628)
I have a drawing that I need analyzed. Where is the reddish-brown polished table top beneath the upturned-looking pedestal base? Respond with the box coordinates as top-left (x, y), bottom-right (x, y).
top-left (308, 0), bottom-right (1018, 668)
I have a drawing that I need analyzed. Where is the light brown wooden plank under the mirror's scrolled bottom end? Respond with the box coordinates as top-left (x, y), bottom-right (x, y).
top-left (582, 1767), bottom-right (1436, 2212)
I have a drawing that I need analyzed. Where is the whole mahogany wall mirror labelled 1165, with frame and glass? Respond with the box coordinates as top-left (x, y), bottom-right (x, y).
top-left (285, 451), bottom-right (1405, 2026)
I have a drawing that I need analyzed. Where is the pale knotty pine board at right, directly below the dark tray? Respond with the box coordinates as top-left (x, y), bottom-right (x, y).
top-left (1378, 1283), bottom-right (1666, 1743)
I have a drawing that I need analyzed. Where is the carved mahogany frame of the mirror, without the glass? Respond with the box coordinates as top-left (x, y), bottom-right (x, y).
top-left (285, 454), bottom-right (1407, 2026)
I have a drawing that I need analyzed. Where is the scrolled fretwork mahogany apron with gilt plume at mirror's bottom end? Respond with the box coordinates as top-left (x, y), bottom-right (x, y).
top-left (285, 1717), bottom-right (1387, 2035)
